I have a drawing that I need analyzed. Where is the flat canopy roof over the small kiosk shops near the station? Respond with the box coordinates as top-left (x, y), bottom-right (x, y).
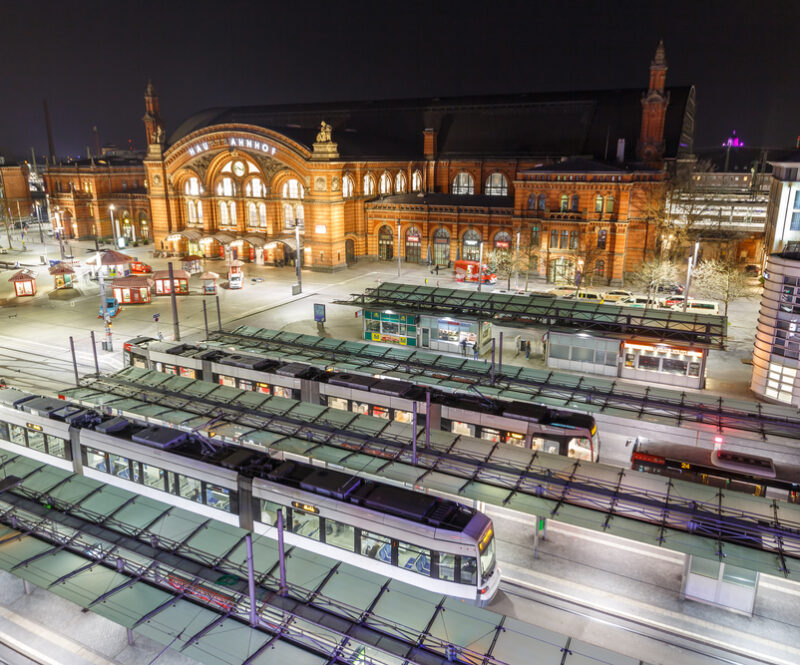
top-left (334, 282), bottom-right (728, 349)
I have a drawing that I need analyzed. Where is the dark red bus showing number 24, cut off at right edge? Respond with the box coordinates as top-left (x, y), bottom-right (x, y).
top-left (631, 437), bottom-right (800, 503)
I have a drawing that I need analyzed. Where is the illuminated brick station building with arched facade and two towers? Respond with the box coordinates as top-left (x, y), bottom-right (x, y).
top-left (133, 44), bottom-right (695, 285)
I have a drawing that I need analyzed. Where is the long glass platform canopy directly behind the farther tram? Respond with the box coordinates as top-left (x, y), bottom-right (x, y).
top-left (189, 326), bottom-right (800, 439)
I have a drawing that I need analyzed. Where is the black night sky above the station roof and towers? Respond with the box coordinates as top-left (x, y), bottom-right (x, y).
top-left (0, 0), bottom-right (800, 158)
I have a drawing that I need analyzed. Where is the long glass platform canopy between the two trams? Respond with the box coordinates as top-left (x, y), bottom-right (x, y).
top-left (63, 367), bottom-right (800, 580)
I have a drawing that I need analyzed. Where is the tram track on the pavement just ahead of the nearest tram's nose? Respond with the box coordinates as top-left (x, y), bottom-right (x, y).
top-left (495, 578), bottom-right (797, 665)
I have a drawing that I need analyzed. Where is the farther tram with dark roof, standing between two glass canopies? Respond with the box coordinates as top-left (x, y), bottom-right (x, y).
top-left (123, 337), bottom-right (600, 462)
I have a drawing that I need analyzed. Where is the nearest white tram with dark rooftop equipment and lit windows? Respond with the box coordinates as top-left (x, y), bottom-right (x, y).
top-left (0, 388), bottom-right (500, 606)
